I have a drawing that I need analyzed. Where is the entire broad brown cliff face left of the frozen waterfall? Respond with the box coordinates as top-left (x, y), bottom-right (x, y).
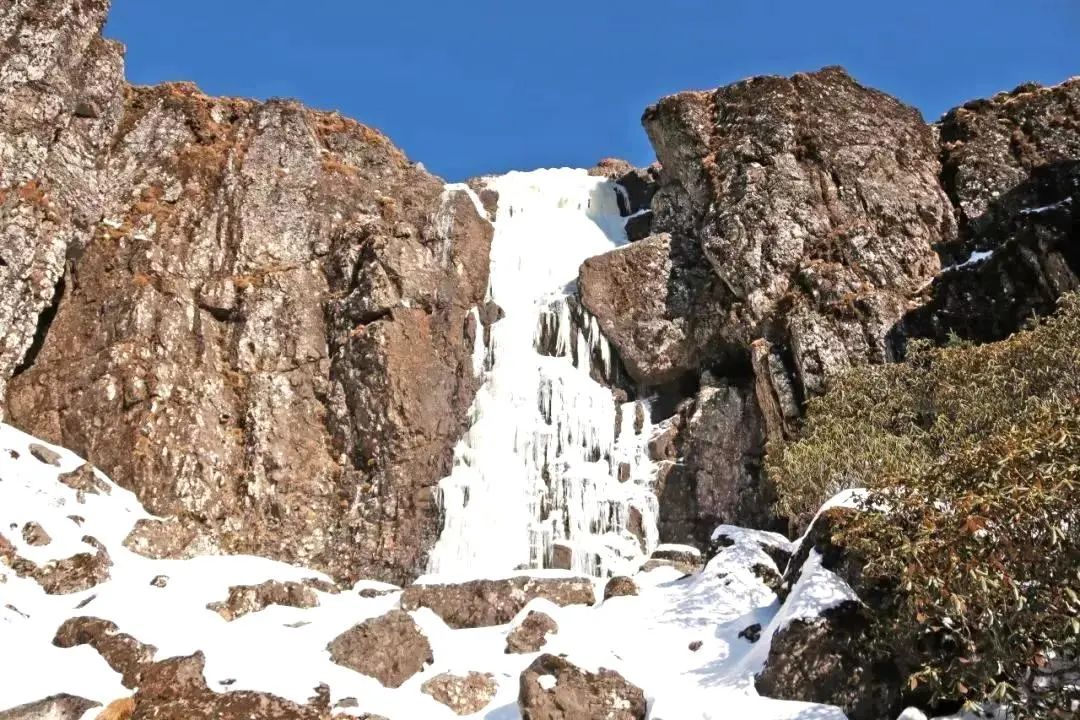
top-left (0, 0), bottom-right (491, 582)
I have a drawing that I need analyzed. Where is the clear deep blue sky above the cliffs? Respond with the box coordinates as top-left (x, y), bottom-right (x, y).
top-left (107, 0), bottom-right (1080, 180)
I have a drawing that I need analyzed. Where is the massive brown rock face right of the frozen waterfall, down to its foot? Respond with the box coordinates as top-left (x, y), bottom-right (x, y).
top-left (579, 68), bottom-right (957, 547)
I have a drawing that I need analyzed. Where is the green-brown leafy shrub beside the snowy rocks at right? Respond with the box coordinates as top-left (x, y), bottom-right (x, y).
top-left (768, 296), bottom-right (1080, 718)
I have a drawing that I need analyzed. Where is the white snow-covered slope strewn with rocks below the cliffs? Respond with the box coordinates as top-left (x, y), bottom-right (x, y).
top-left (0, 425), bottom-right (868, 720)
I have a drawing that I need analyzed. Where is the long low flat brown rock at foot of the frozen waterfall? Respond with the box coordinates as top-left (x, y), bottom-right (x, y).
top-left (402, 576), bottom-right (596, 628)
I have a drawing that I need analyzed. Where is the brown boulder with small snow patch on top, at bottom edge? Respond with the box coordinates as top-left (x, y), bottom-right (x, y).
top-left (517, 655), bottom-right (646, 720)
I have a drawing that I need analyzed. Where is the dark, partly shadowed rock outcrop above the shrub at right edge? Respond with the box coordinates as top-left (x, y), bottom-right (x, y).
top-left (903, 79), bottom-right (1080, 341)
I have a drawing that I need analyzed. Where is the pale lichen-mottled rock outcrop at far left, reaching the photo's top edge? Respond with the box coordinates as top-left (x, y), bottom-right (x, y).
top-left (0, 0), bottom-right (123, 405)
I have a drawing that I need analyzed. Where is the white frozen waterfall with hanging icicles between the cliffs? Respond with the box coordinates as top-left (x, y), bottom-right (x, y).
top-left (429, 169), bottom-right (657, 578)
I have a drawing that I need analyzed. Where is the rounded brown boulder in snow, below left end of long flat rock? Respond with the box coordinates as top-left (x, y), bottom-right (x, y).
top-left (326, 610), bottom-right (434, 688)
